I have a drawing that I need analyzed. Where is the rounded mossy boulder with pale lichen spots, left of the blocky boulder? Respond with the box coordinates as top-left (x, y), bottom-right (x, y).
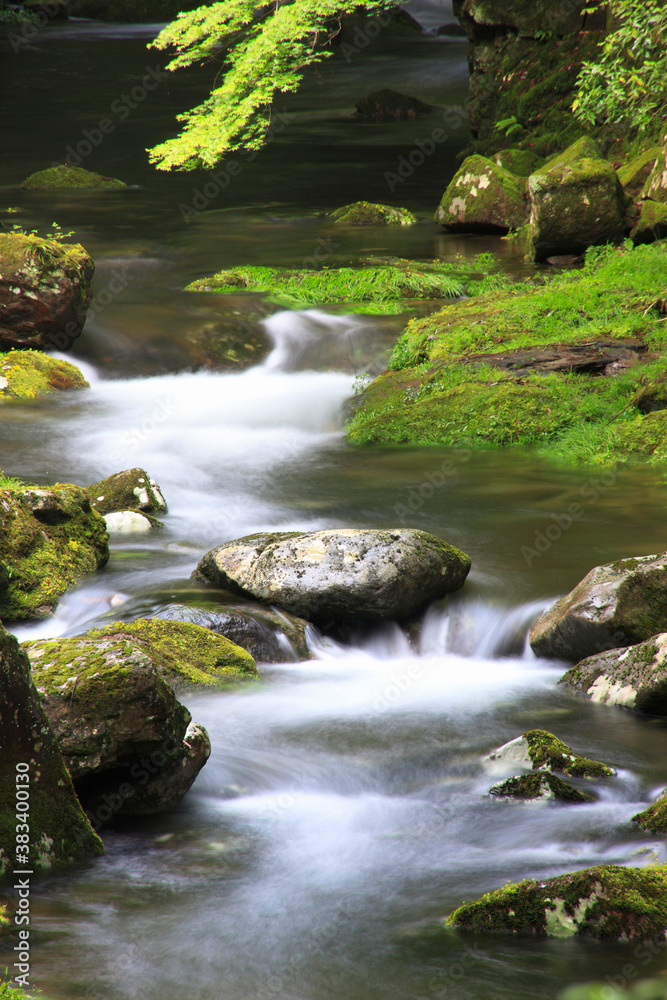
top-left (435, 155), bottom-right (528, 233)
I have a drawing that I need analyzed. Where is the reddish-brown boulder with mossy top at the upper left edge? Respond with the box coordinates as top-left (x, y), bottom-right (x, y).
top-left (0, 233), bottom-right (95, 350)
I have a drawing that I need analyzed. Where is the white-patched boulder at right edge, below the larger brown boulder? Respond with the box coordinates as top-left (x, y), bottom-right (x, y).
top-left (560, 632), bottom-right (667, 715)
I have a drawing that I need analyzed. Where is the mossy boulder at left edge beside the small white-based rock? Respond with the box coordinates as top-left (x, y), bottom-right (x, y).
top-left (0, 483), bottom-right (109, 621)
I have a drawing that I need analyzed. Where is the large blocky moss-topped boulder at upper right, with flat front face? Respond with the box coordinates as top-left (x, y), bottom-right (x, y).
top-left (528, 136), bottom-right (626, 261)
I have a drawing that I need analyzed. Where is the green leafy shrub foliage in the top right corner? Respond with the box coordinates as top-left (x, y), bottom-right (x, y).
top-left (572, 0), bottom-right (667, 134)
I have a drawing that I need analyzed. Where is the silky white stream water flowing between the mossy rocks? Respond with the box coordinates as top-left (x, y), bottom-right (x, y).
top-left (0, 4), bottom-right (667, 1000)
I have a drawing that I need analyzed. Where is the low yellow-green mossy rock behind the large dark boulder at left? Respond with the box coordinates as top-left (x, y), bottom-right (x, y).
top-left (75, 618), bottom-right (258, 689)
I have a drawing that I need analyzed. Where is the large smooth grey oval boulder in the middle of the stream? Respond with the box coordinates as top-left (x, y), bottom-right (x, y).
top-left (193, 528), bottom-right (470, 623)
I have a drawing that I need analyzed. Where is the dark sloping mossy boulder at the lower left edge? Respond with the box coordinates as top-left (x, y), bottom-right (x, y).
top-left (0, 627), bottom-right (104, 879)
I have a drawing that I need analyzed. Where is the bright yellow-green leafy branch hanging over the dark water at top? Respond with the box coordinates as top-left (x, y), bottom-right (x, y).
top-left (149, 0), bottom-right (398, 170)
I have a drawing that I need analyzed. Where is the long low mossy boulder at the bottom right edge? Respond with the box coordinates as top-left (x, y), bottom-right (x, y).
top-left (445, 865), bottom-right (667, 941)
